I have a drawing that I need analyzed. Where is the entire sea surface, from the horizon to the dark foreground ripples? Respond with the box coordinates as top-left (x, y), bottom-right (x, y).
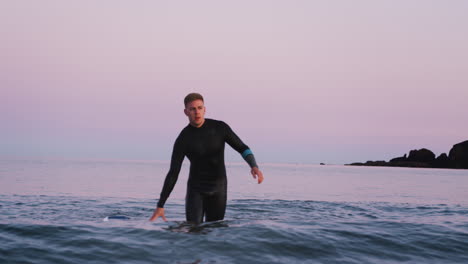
top-left (0, 159), bottom-right (468, 263)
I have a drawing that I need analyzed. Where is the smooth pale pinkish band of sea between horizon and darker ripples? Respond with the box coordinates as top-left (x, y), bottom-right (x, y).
top-left (0, 160), bottom-right (468, 206)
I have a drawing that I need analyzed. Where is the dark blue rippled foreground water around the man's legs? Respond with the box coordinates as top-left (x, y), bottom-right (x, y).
top-left (0, 196), bottom-right (468, 263)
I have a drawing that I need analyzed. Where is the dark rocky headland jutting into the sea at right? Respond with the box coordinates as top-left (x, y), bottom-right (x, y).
top-left (348, 140), bottom-right (468, 169)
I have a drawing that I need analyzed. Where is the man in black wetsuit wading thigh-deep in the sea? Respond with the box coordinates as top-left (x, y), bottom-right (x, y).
top-left (150, 93), bottom-right (263, 223)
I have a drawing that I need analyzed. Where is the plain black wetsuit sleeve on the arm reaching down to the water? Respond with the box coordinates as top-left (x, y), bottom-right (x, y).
top-left (158, 135), bottom-right (185, 208)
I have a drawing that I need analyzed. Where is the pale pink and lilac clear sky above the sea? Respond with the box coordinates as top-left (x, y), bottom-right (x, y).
top-left (0, 0), bottom-right (468, 164)
